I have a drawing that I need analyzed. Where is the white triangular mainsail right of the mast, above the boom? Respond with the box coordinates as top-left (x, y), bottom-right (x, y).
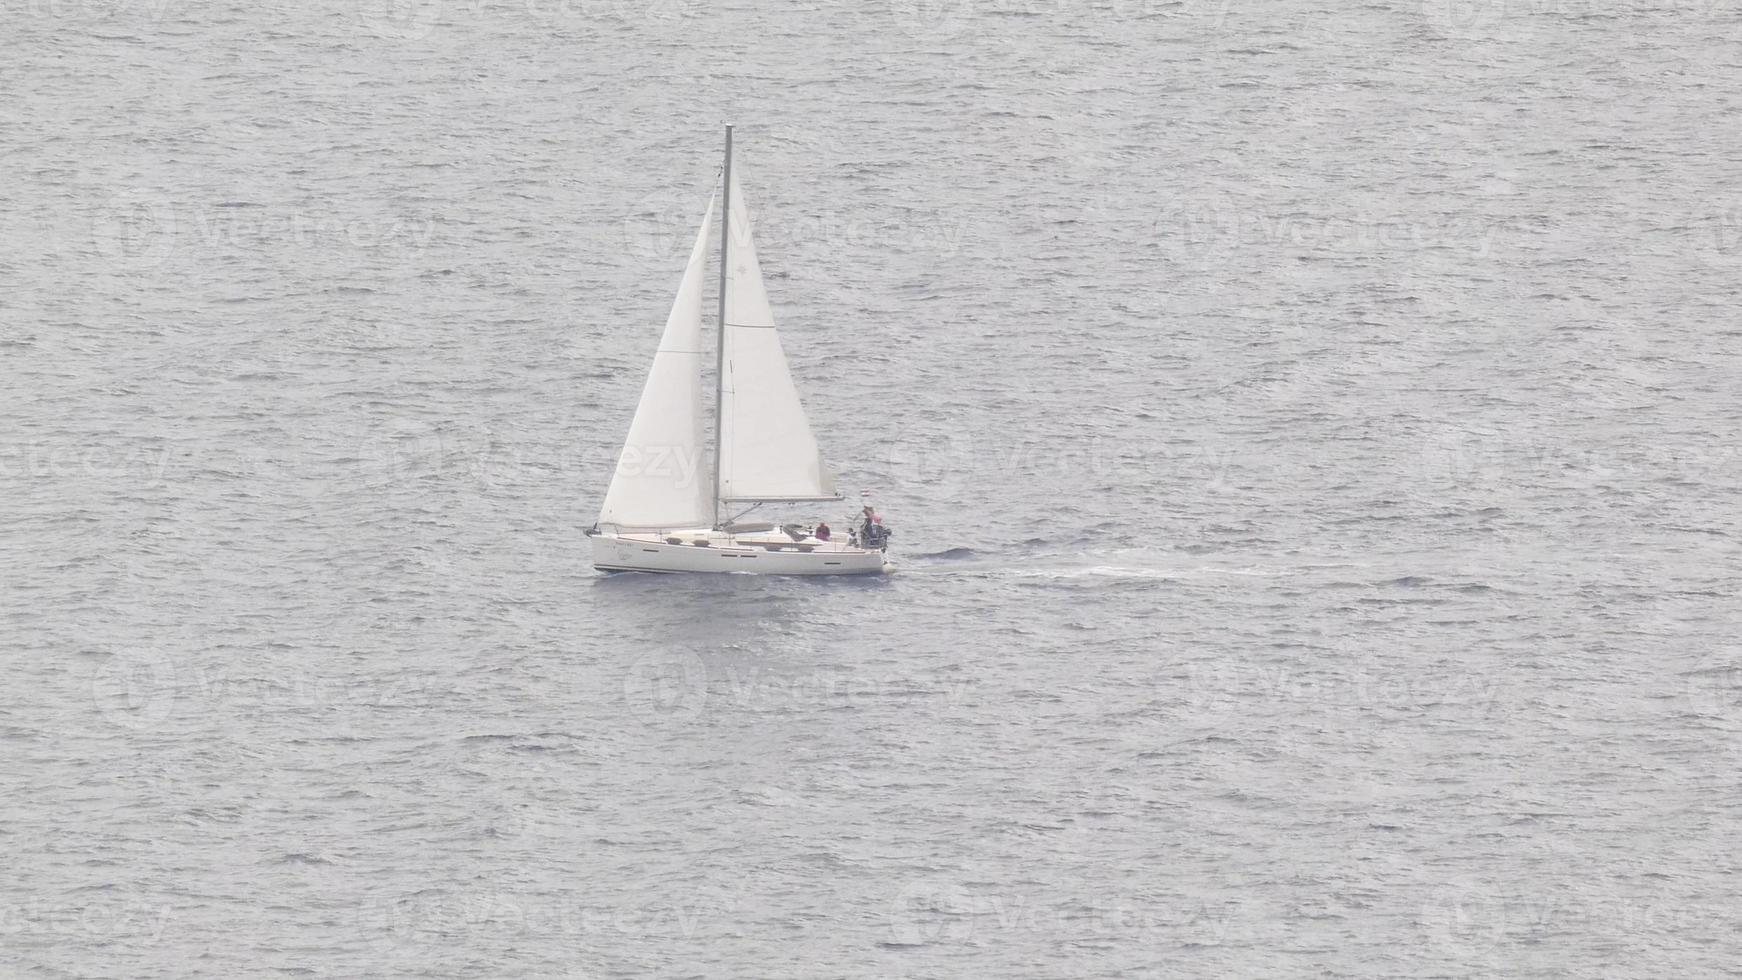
top-left (719, 174), bottom-right (840, 501)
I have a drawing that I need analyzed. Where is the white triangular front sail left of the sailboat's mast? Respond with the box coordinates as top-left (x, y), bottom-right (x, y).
top-left (599, 198), bottom-right (714, 529)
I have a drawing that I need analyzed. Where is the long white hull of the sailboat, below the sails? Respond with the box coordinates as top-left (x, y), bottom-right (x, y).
top-left (592, 531), bottom-right (895, 574)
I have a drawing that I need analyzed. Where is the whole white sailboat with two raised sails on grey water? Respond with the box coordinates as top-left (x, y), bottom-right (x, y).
top-left (587, 125), bottom-right (894, 574)
